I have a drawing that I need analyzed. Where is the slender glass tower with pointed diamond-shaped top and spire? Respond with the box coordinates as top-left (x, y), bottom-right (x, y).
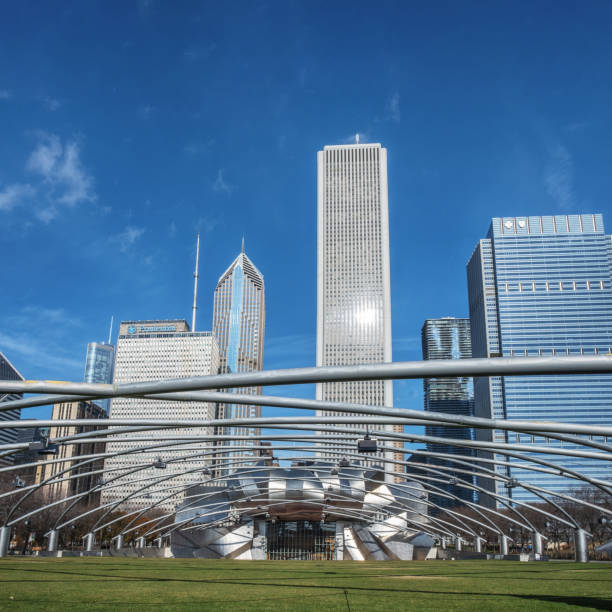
top-left (213, 240), bottom-right (266, 464)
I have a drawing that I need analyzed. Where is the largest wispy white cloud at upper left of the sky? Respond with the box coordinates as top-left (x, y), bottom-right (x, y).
top-left (26, 134), bottom-right (97, 206)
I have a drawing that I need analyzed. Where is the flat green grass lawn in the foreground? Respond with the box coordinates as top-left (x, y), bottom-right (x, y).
top-left (0, 557), bottom-right (612, 612)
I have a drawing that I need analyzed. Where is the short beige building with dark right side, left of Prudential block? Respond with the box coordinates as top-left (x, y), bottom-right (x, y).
top-left (36, 401), bottom-right (108, 504)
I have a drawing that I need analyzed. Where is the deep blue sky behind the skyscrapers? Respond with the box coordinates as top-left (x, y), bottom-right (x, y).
top-left (0, 0), bottom-right (612, 424)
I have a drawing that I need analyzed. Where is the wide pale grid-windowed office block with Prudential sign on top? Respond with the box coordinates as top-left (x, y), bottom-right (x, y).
top-left (102, 319), bottom-right (219, 511)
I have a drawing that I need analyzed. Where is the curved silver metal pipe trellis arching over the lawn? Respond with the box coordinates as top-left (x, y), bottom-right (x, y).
top-left (0, 355), bottom-right (612, 562)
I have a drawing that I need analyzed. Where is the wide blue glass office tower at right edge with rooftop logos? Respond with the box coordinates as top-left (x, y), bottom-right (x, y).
top-left (467, 215), bottom-right (612, 504)
